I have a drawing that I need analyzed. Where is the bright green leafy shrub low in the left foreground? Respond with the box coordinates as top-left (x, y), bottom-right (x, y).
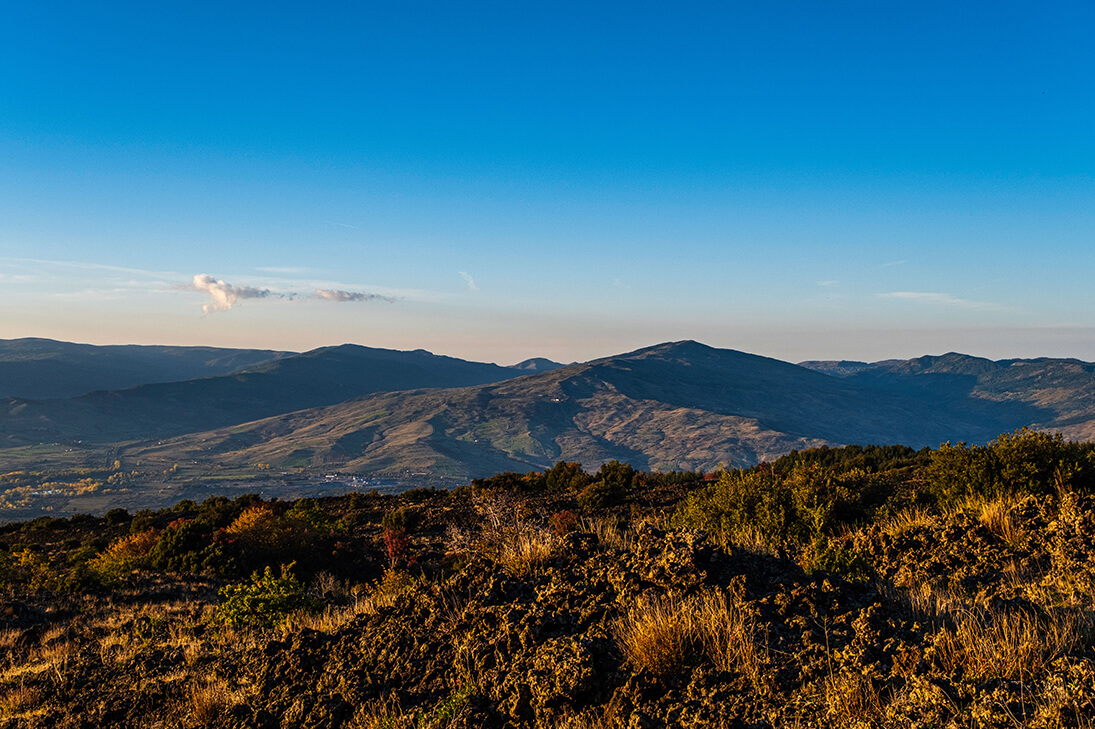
top-left (217, 564), bottom-right (318, 628)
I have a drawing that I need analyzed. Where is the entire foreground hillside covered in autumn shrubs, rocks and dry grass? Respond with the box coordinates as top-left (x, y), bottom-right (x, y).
top-left (0, 431), bottom-right (1095, 729)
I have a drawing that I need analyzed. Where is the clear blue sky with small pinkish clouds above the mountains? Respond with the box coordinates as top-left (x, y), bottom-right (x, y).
top-left (0, 0), bottom-right (1095, 363)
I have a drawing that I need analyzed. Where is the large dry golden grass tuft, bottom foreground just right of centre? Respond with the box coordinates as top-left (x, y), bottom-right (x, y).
top-left (613, 592), bottom-right (768, 691)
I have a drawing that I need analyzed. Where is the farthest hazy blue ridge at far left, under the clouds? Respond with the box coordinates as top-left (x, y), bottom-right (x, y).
top-left (0, 338), bottom-right (292, 400)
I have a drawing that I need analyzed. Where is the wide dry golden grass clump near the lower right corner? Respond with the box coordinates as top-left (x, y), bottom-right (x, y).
top-left (936, 610), bottom-right (1080, 680)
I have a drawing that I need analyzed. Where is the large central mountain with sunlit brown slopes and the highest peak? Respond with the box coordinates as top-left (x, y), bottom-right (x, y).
top-left (129, 342), bottom-right (1073, 477)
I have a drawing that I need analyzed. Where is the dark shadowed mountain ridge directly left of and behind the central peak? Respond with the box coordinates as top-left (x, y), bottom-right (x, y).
top-left (0, 345), bottom-right (522, 444)
